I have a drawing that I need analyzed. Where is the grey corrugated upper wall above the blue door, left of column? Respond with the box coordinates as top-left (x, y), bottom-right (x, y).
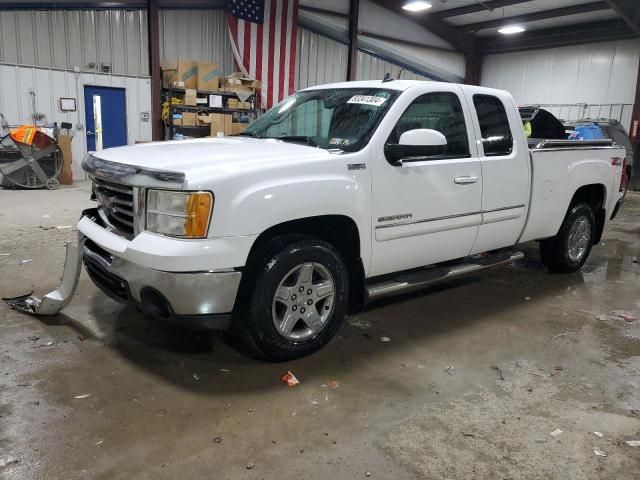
top-left (0, 10), bottom-right (149, 76)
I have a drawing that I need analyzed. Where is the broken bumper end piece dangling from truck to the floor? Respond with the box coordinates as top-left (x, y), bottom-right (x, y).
top-left (2, 234), bottom-right (86, 316)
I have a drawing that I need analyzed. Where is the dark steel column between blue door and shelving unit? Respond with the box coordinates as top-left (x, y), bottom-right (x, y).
top-left (147, 0), bottom-right (162, 141)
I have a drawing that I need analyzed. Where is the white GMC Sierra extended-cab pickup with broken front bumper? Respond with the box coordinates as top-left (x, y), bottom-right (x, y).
top-left (9, 81), bottom-right (627, 361)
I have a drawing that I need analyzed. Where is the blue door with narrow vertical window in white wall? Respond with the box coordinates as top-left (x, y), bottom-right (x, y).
top-left (84, 87), bottom-right (127, 151)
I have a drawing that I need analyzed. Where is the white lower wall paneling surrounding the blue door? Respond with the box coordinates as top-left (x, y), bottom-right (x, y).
top-left (0, 65), bottom-right (151, 180)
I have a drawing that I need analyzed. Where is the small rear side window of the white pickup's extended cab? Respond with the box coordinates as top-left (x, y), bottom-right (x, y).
top-left (473, 95), bottom-right (513, 157)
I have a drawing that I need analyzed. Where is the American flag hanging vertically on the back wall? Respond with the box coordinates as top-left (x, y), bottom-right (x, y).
top-left (226, 0), bottom-right (298, 108)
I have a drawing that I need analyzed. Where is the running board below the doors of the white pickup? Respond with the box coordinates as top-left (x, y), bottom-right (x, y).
top-left (367, 249), bottom-right (524, 301)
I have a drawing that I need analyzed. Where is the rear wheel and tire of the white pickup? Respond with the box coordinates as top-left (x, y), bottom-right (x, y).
top-left (540, 203), bottom-right (596, 273)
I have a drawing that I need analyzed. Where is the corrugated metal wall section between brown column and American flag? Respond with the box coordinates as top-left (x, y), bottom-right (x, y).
top-left (160, 10), bottom-right (235, 74)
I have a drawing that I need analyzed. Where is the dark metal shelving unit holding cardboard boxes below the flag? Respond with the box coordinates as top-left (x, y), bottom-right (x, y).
top-left (162, 87), bottom-right (258, 140)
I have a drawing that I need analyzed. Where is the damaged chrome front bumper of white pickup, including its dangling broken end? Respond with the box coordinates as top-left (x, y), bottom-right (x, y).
top-left (3, 209), bottom-right (242, 329)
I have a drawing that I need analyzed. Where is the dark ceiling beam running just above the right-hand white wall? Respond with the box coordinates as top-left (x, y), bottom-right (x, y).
top-left (478, 19), bottom-right (638, 55)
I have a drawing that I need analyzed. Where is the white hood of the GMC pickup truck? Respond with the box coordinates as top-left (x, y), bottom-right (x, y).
top-left (93, 137), bottom-right (333, 180)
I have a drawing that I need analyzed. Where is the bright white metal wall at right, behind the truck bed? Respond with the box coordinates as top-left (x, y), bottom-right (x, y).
top-left (482, 40), bottom-right (640, 129)
